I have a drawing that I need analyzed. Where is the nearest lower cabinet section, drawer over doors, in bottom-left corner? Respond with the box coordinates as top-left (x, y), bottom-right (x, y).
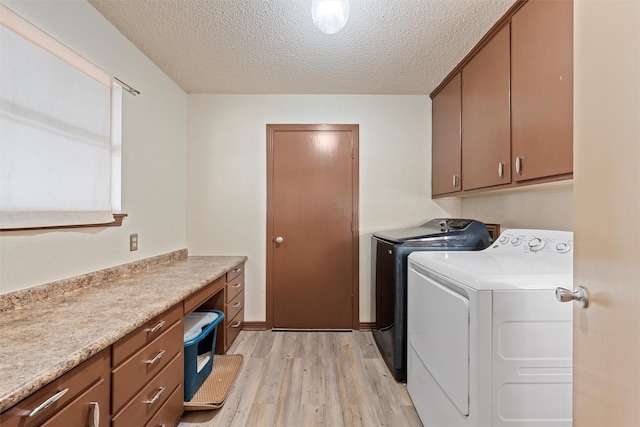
top-left (0, 349), bottom-right (110, 427)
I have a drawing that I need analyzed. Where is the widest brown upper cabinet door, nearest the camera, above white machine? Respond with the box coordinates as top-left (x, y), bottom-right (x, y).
top-left (511, 1), bottom-right (573, 181)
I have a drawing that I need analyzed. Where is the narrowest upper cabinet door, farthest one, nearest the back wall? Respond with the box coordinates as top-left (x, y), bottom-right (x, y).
top-left (431, 74), bottom-right (462, 196)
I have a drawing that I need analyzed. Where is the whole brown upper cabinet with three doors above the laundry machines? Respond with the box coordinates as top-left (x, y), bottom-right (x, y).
top-left (431, 0), bottom-right (573, 197)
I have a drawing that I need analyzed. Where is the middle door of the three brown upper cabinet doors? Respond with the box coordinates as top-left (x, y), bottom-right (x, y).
top-left (462, 25), bottom-right (511, 190)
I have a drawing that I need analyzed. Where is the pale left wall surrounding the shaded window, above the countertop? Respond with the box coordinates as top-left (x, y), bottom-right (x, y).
top-left (0, 0), bottom-right (187, 294)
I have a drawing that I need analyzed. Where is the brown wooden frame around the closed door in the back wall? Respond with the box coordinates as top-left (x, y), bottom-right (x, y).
top-left (265, 124), bottom-right (360, 330)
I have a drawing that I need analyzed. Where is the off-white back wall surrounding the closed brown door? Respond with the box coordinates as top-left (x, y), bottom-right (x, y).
top-left (187, 95), bottom-right (459, 322)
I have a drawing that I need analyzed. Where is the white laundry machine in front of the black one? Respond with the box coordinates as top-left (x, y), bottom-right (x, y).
top-left (407, 229), bottom-right (573, 427)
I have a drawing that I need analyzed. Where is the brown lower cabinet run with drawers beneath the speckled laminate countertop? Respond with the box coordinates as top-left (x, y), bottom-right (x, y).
top-left (0, 264), bottom-right (244, 427)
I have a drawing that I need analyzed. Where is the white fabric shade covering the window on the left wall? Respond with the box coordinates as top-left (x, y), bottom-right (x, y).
top-left (0, 4), bottom-right (119, 229)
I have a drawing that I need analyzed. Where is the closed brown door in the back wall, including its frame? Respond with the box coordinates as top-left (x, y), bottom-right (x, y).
top-left (267, 125), bottom-right (358, 329)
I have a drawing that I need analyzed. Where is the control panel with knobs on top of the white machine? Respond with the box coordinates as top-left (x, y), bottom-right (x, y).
top-left (485, 229), bottom-right (573, 255)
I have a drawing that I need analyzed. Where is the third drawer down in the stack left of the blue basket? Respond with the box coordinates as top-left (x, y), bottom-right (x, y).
top-left (111, 353), bottom-right (184, 427)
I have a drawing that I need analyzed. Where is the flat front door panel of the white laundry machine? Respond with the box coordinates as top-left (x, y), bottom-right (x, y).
top-left (409, 265), bottom-right (470, 416)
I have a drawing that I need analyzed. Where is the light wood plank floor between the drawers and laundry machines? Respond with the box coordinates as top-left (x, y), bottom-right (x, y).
top-left (179, 331), bottom-right (422, 427)
